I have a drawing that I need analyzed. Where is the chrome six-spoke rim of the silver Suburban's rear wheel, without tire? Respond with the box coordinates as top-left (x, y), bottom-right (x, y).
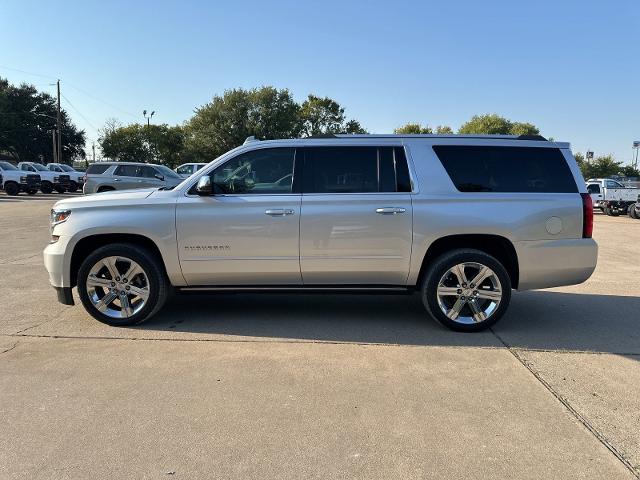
top-left (437, 262), bottom-right (502, 325)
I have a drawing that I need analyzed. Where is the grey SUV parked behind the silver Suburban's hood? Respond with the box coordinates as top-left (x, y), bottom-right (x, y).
top-left (82, 162), bottom-right (184, 194)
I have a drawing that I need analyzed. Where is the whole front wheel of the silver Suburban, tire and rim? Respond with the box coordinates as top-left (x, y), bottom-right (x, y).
top-left (78, 243), bottom-right (169, 326)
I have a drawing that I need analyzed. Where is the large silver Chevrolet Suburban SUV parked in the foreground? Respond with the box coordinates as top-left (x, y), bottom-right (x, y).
top-left (44, 135), bottom-right (597, 331)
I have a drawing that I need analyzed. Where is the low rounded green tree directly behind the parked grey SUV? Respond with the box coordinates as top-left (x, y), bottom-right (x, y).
top-left (98, 123), bottom-right (184, 168)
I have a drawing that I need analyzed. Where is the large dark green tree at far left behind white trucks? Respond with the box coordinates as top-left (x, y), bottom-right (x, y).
top-left (0, 78), bottom-right (85, 163)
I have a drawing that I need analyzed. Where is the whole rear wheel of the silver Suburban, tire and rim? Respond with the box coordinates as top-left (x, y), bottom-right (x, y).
top-left (421, 249), bottom-right (511, 332)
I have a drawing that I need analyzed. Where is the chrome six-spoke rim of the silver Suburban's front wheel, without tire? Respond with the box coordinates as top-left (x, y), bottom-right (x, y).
top-left (86, 256), bottom-right (149, 318)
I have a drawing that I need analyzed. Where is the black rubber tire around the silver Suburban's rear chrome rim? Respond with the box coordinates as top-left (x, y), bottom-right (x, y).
top-left (420, 249), bottom-right (511, 332)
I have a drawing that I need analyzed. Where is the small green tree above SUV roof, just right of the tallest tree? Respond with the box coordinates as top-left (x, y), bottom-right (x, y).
top-left (300, 95), bottom-right (367, 137)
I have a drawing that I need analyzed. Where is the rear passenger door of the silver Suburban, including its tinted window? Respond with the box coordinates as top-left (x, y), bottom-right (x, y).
top-left (300, 146), bottom-right (412, 285)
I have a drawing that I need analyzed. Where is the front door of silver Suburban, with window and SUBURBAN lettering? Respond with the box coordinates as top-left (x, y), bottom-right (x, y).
top-left (176, 148), bottom-right (302, 286)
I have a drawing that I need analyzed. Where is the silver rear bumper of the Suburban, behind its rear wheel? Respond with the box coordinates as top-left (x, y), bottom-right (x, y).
top-left (515, 238), bottom-right (598, 290)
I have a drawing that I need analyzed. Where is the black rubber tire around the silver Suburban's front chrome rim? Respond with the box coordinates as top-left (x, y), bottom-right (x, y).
top-left (78, 243), bottom-right (171, 327)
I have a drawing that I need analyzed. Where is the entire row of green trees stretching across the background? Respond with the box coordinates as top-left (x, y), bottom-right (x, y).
top-left (0, 78), bottom-right (640, 178)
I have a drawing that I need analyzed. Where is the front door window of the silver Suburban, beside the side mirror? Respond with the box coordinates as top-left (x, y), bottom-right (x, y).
top-left (213, 148), bottom-right (295, 194)
